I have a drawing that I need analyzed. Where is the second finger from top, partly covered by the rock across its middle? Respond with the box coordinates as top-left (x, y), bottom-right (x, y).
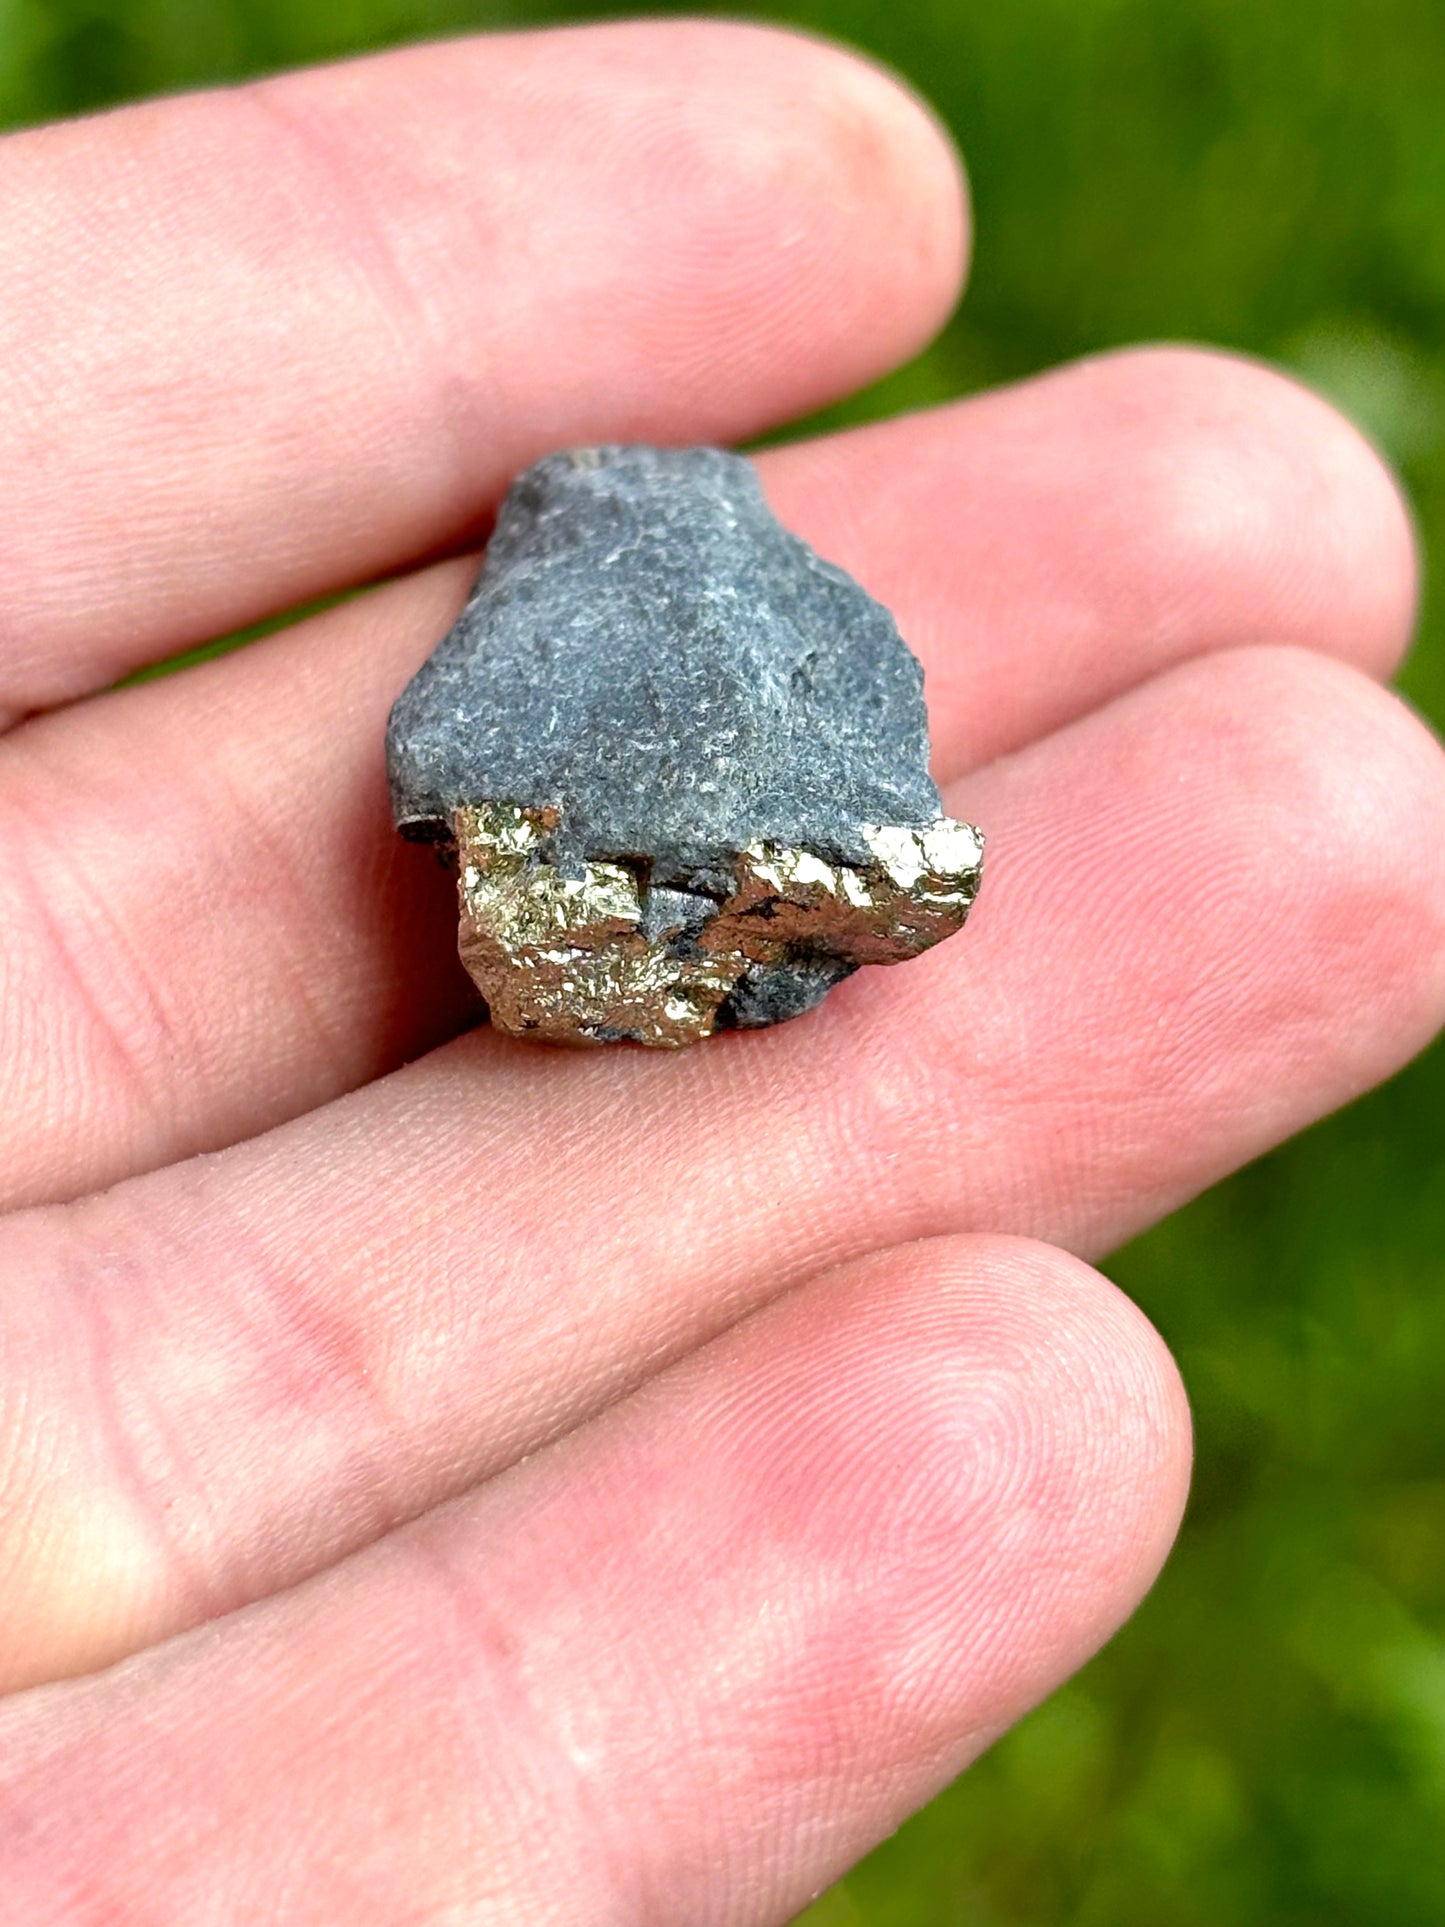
top-left (0, 351), bottom-right (1414, 1202)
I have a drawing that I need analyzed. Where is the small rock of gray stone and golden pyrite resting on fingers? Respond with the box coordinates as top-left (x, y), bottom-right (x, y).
top-left (387, 447), bottom-right (983, 1046)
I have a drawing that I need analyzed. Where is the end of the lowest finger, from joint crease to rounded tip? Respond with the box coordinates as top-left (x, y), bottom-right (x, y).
top-left (487, 1237), bottom-right (1189, 1921)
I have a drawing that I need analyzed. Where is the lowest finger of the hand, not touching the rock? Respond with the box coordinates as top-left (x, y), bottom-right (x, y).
top-left (0, 1239), bottom-right (1189, 1927)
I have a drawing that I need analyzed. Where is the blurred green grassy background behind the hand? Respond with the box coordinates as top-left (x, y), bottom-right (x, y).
top-left (0, 0), bottom-right (1445, 1927)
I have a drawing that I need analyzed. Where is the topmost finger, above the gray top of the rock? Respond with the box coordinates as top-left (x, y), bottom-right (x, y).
top-left (0, 21), bottom-right (963, 717)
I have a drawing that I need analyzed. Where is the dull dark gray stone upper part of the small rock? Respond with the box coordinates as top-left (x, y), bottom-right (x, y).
top-left (387, 447), bottom-right (940, 871)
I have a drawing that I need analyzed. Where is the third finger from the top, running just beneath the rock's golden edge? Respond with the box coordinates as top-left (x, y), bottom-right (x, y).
top-left (0, 649), bottom-right (1445, 1671)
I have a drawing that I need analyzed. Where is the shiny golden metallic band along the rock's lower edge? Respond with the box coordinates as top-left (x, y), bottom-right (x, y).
top-left (453, 804), bottom-right (983, 1048)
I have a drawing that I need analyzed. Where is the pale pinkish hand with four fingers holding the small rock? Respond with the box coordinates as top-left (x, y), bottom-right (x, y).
top-left (0, 23), bottom-right (1445, 1927)
